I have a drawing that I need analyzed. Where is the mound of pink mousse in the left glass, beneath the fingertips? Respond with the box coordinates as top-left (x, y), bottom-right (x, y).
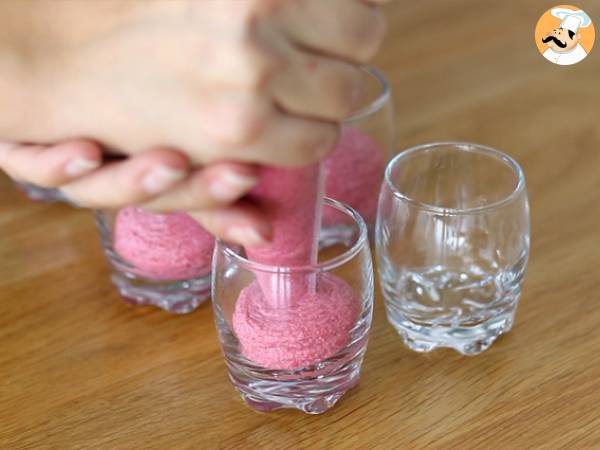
top-left (114, 207), bottom-right (215, 280)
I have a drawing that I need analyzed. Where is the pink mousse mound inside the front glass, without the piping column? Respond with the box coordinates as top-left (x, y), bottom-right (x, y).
top-left (233, 273), bottom-right (359, 370)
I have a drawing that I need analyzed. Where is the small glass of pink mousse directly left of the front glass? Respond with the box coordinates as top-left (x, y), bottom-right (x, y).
top-left (95, 207), bottom-right (214, 314)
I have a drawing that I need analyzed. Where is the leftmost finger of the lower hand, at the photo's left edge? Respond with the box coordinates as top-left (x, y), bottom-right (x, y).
top-left (0, 140), bottom-right (102, 187)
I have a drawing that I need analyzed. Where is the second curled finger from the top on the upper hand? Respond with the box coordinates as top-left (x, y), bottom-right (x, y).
top-left (271, 49), bottom-right (365, 120)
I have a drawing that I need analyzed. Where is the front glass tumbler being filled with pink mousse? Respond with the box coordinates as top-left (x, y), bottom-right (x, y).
top-left (212, 199), bottom-right (373, 414)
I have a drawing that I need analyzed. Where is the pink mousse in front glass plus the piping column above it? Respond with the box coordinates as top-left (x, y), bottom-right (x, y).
top-left (233, 165), bottom-right (358, 369)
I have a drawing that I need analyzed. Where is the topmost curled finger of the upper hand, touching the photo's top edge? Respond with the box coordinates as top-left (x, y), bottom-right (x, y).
top-left (280, 0), bottom-right (385, 63)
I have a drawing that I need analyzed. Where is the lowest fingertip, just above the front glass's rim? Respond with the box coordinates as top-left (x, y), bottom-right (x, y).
top-left (190, 202), bottom-right (273, 247)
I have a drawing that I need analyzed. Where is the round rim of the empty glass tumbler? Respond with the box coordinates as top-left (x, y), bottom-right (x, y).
top-left (384, 141), bottom-right (525, 216)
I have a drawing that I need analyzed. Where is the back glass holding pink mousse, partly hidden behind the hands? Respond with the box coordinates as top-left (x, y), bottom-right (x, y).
top-left (323, 66), bottom-right (395, 238)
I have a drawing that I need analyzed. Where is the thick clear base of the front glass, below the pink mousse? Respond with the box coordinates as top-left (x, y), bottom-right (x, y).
top-left (229, 351), bottom-right (364, 414)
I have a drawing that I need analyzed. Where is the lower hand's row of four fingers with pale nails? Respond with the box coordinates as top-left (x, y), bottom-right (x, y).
top-left (0, 140), bottom-right (271, 245)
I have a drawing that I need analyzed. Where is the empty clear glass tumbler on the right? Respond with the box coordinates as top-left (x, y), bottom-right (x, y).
top-left (375, 142), bottom-right (530, 355)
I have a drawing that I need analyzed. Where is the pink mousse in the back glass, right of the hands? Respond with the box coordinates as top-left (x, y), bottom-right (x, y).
top-left (323, 126), bottom-right (385, 225)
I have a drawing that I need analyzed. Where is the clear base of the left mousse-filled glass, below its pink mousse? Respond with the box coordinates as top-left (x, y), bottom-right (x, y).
top-left (111, 273), bottom-right (211, 314)
